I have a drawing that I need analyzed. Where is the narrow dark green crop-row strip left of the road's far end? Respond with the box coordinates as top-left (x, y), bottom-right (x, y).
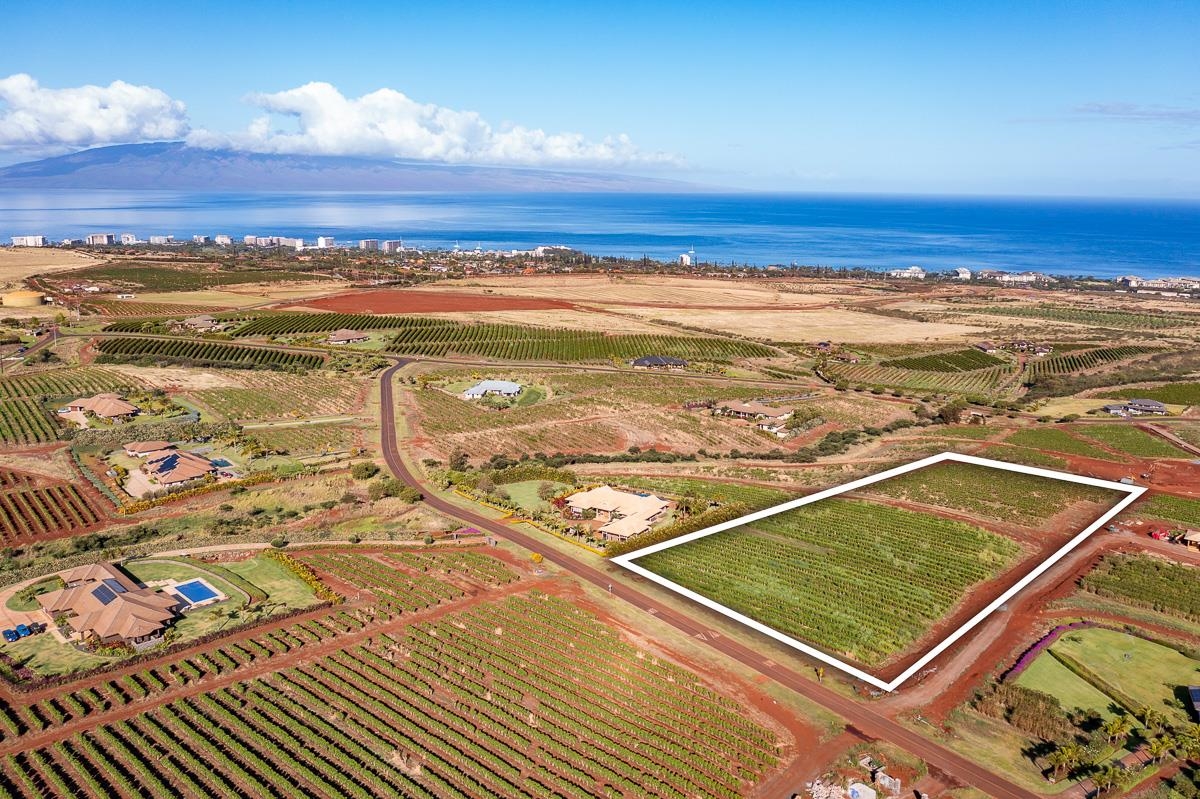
top-left (96, 338), bottom-right (324, 370)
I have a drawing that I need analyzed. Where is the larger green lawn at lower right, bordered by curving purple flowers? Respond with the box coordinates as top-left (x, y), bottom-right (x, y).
top-left (1054, 627), bottom-right (1200, 721)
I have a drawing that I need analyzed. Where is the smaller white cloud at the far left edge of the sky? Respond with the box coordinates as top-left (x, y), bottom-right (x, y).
top-left (0, 73), bottom-right (188, 152)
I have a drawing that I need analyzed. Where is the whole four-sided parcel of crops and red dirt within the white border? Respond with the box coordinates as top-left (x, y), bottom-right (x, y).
top-left (617, 453), bottom-right (1140, 690)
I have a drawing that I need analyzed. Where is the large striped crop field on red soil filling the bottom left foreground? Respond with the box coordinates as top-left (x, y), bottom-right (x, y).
top-left (5, 587), bottom-right (776, 798)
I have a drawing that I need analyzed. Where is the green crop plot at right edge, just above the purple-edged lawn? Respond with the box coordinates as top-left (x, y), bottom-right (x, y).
top-left (1080, 554), bottom-right (1200, 621)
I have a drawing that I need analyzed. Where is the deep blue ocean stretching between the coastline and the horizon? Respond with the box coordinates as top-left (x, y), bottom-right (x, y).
top-left (0, 190), bottom-right (1200, 277)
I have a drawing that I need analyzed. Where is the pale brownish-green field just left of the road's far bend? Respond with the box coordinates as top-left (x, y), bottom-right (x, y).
top-left (188, 372), bottom-right (366, 421)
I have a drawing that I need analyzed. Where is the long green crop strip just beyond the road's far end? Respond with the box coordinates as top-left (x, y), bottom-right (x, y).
top-left (388, 320), bottom-right (775, 362)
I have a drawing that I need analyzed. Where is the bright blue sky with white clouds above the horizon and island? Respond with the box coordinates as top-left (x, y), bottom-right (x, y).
top-left (0, 0), bottom-right (1200, 197)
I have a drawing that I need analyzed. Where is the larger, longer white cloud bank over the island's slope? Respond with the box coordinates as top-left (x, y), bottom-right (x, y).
top-left (187, 83), bottom-right (679, 167)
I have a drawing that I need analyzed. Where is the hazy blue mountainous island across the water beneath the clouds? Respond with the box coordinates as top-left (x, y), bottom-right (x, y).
top-left (0, 142), bottom-right (698, 192)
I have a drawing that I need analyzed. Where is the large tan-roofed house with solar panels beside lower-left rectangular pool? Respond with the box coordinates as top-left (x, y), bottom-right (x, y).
top-left (37, 563), bottom-right (179, 649)
